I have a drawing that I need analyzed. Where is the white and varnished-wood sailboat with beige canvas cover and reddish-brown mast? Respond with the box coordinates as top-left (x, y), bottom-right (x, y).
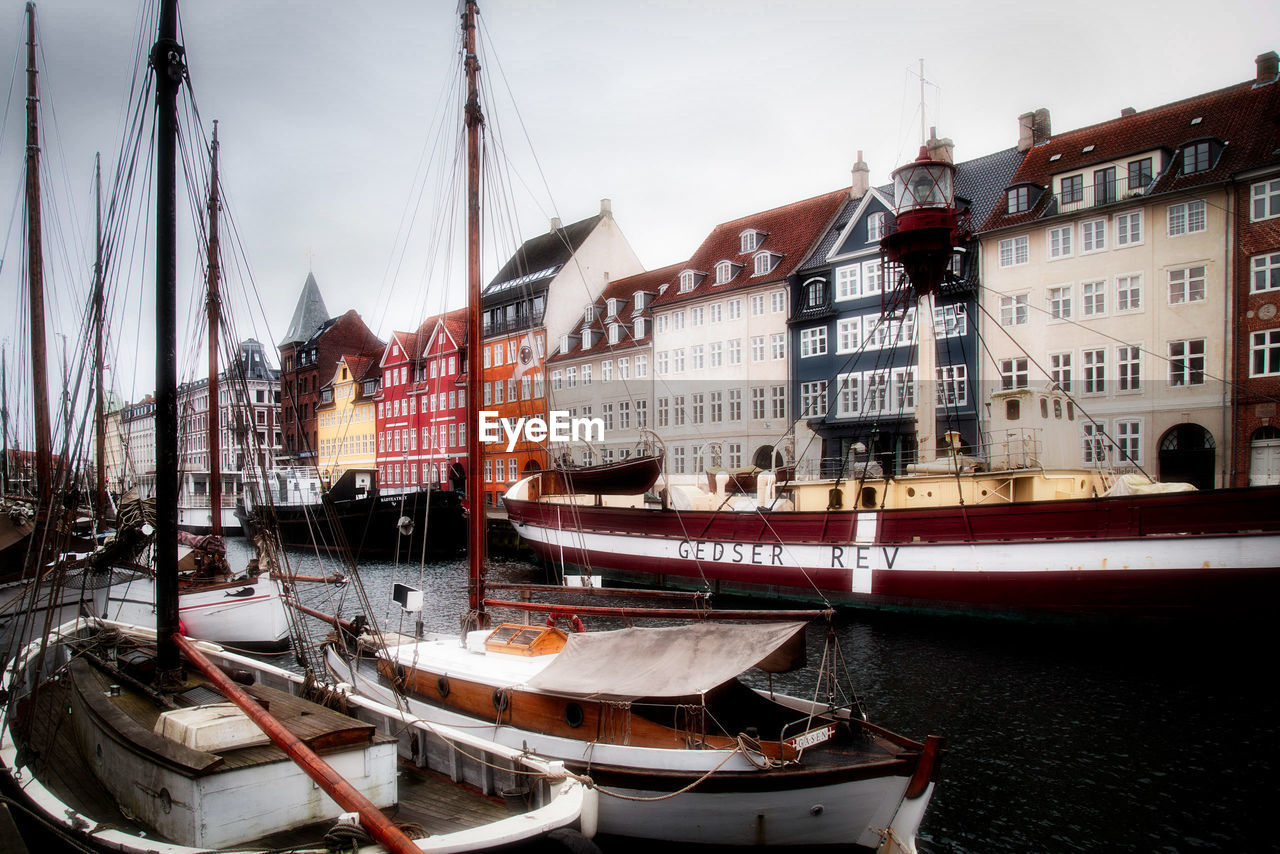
top-left (328, 0), bottom-right (942, 851)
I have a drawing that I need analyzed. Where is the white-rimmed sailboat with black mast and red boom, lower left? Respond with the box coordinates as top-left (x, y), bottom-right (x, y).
top-left (0, 0), bottom-right (591, 854)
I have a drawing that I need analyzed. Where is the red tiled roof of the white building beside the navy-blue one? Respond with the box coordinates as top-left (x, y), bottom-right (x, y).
top-left (654, 187), bottom-right (849, 306)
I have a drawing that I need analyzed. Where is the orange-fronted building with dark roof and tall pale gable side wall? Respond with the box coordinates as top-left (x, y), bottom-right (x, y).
top-left (480, 198), bottom-right (644, 504)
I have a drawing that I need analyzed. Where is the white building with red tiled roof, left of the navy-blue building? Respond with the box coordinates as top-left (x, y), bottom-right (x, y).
top-left (650, 188), bottom-right (849, 483)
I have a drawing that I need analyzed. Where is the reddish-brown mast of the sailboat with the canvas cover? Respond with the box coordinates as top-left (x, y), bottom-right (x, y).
top-left (462, 0), bottom-right (489, 629)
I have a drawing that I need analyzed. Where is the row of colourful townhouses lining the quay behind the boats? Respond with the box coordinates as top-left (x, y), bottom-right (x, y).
top-left (107, 52), bottom-right (1280, 503)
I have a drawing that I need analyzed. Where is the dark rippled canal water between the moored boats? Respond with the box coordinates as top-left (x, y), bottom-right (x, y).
top-left (241, 540), bottom-right (1280, 854)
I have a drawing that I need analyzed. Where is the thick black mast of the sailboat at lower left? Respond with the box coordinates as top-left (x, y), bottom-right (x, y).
top-left (151, 0), bottom-right (186, 684)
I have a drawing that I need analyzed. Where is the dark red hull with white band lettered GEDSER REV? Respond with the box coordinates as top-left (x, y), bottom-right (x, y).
top-left (506, 489), bottom-right (1280, 616)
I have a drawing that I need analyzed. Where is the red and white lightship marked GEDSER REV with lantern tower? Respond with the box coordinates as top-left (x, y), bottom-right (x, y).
top-left (503, 140), bottom-right (1280, 620)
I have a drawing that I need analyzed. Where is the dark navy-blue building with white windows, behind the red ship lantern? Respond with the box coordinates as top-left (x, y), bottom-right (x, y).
top-left (788, 142), bottom-right (1023, 478)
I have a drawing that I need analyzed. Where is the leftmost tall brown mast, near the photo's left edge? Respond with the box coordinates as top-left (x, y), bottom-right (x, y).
top-left (27, 3), bottom-right (54, 512)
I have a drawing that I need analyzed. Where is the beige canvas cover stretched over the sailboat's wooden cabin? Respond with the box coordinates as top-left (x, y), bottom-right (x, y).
top-left (529, 622), bottom-right (805, 699)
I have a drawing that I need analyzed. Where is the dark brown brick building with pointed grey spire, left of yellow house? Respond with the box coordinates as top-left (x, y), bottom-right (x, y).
top-left (279, 273), bottom-right (383, 466)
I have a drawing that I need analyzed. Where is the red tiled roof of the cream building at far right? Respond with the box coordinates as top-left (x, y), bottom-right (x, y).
top-left (980, 79), bottom-right (1280, 230)
